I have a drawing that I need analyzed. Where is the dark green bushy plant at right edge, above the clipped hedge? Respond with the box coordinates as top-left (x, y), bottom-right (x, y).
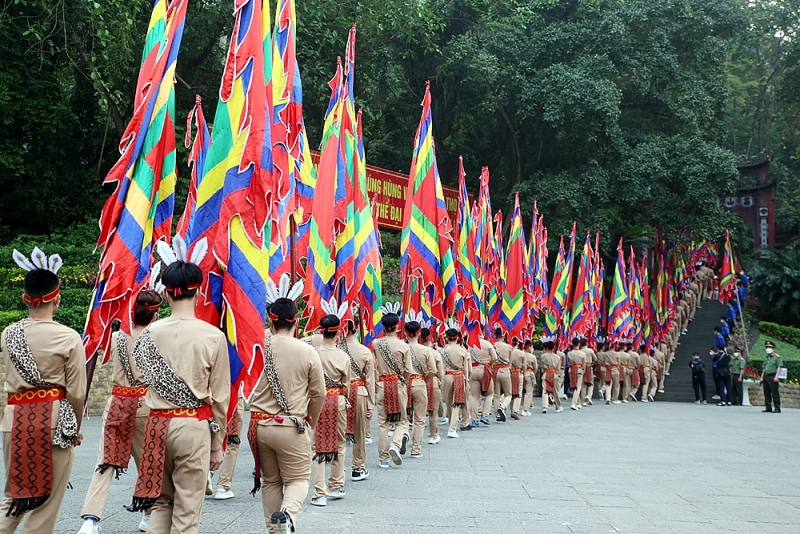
top-left (748, 248), bottom-right (800, 327)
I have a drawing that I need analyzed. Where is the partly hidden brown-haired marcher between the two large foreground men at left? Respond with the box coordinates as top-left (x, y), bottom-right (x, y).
top-left (78, 290), bottom-right (161, 534)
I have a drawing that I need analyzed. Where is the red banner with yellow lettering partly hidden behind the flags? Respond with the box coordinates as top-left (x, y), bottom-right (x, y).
top-left (311, 151), bottom-right (472, 230)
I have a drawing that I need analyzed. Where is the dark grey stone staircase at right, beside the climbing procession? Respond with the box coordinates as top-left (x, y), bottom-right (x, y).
top-left (656, 300), bottom-right (728, 403)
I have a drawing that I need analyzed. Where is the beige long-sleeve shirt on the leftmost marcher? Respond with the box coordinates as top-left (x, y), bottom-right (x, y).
top-left (0, 319), bottom-right (86, 432)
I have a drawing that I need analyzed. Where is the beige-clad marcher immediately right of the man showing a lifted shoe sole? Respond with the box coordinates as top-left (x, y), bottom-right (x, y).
top-left (405, 321), bottom-right (436, 458)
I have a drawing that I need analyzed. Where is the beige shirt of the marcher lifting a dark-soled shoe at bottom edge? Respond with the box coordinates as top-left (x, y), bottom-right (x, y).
top-left (250, 332), bottom-right (324, 432)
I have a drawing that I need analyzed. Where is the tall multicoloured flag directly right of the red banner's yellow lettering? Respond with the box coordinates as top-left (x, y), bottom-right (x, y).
top-left (400, 82), bottom-right (457, 322)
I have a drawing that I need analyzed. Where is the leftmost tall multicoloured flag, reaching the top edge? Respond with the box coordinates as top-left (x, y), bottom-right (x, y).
top-left (83, 0), bottom-right (187, 363)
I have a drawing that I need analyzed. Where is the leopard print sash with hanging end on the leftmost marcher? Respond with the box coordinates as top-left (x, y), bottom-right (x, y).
top-left (6, 319), bottom-right (78, 449)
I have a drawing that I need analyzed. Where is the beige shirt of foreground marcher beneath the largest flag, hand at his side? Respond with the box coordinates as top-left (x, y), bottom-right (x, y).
top-left (145, 317), bottom-right (231, 451)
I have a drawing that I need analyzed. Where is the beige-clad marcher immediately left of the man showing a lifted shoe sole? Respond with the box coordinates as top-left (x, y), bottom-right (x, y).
top-left (340, 321), bottom-right (375, 481)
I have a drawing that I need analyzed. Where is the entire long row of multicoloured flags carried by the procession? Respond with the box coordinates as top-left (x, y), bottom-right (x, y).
top-left (78, 0), bottom-right (735, 418)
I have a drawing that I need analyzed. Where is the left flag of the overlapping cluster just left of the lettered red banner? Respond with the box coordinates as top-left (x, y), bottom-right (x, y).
top-left (304, 60), bottom-right (347, 332)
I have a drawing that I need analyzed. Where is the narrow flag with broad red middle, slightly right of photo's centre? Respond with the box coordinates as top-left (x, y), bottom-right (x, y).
top-left (500, 193), bottom-right (529, 341)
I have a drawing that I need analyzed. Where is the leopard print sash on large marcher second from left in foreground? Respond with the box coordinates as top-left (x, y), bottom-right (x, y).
top-left (133, 327), bottom-right (220, 432)
